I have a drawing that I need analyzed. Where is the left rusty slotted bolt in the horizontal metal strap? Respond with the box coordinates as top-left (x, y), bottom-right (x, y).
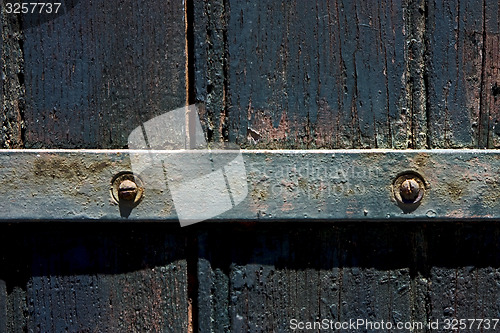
top-left (110, 171), bottom-right (144, 206)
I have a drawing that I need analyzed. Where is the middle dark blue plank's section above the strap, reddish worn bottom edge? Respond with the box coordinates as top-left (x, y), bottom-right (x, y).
top-left (195, 1), bottom-right (416, 148)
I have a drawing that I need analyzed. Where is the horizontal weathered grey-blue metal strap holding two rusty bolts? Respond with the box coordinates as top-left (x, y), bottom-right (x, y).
top-left (0, 150), bottom-right (500, 224)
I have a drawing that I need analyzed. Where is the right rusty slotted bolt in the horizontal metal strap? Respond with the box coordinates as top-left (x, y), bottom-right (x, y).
top-left (393, 172), bottom-right (425, 205)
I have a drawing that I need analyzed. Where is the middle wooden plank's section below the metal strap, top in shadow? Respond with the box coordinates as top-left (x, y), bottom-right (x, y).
top-left (198, 223), bottom-right (412, 332)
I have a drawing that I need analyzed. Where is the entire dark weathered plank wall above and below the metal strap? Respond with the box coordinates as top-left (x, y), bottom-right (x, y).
top-left (0, 0), bottom-right (500, 332)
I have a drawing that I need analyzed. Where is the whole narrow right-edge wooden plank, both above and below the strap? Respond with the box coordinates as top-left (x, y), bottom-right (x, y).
top-left (420, 0), bottom-right (500, 331)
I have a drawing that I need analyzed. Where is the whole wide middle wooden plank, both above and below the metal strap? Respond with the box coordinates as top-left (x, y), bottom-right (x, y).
top-left (194, 1), bottom-right (422, 332)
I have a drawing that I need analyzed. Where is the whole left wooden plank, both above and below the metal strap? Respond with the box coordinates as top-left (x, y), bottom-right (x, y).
top-left (0, 1), bottom-right (189, 332)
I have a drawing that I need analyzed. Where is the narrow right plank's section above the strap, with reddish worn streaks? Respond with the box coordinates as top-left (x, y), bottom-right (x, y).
top-left (426, 0), bottom-right (500, 148)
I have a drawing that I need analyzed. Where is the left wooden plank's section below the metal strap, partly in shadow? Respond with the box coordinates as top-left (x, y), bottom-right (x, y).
top-left (0, 224), bottom-right (188, 332)
